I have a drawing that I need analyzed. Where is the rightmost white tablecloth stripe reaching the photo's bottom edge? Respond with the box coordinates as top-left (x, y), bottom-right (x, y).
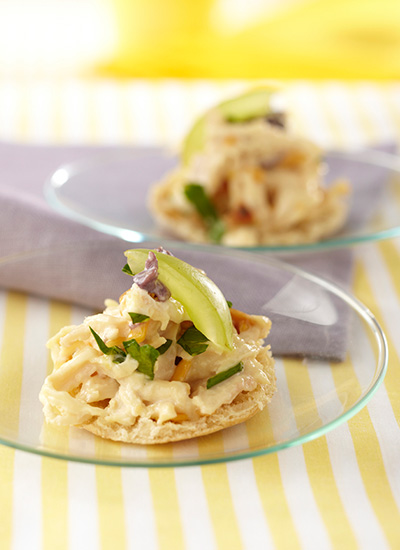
top-left (309, 362), bottom-right (387, 550)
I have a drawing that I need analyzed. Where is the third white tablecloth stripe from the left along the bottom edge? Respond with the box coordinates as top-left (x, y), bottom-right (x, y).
top-left (121, 468), bottom-right (157, 550)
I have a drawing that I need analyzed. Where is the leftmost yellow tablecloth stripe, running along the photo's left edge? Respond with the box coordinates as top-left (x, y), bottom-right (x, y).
top-left (0, 292), bottom-right (27, 548)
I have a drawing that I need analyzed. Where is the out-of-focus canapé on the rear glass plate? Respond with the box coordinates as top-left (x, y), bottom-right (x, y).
top-left (149, 90), bottom-right (349, 247)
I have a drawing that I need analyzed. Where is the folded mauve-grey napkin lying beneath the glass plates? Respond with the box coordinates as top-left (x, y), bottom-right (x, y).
top-left (0, 143), bottom-right (394, 360)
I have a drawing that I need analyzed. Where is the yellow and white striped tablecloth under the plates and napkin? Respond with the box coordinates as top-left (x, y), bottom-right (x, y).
top-left (0, 80), bottom-right (400, 550)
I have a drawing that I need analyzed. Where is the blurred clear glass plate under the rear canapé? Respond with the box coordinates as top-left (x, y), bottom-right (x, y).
top-left (45, 147), bottom-right (400, 252)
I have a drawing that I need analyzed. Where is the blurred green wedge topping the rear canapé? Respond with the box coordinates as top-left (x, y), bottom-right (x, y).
top-left (182, 87), bottom-right (276, 164)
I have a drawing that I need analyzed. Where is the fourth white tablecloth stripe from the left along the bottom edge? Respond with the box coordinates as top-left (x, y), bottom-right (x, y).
top-left (175, 467), bottom-right (216, 550)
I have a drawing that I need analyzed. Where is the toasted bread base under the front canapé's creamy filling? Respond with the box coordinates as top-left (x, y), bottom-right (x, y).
top-left (82, 353), bottom-right (276, 445)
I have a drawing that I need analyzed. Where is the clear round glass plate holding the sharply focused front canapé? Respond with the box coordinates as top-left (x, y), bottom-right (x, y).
top-left (0, 242), bottom-right (387, 467)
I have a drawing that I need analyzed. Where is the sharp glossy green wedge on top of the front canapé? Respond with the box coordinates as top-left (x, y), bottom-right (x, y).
top-left (125, 248), bottom-right (233, 350)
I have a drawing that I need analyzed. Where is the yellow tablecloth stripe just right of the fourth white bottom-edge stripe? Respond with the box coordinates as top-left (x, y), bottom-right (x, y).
top-left (198, 432), bottom-right (243, 550)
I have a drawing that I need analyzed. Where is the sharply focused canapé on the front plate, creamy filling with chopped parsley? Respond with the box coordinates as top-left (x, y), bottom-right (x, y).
top-left (40, 249), bottom-right (276, 444)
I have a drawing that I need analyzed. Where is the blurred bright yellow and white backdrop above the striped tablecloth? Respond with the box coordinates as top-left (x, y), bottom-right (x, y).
top-left (0, 0), bottom-right (400, 80)
